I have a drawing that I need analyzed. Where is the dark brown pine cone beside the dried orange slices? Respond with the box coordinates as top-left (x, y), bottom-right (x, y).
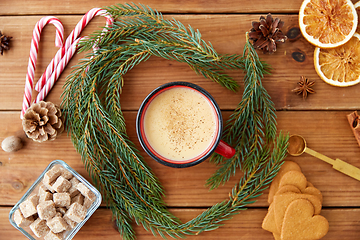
top-left (249, 13), bottom-right (287, 53)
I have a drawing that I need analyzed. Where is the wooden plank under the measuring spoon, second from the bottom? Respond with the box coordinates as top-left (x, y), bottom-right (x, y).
top-left (0, 111), bottom-right (360, 207)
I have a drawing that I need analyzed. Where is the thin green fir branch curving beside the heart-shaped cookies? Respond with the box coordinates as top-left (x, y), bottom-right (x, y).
top-left (174, 134), bottom-right (288, 235)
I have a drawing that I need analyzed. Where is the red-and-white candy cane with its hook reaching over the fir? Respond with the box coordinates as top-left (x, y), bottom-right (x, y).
top-left (35, 8), bottom-right (114, 92)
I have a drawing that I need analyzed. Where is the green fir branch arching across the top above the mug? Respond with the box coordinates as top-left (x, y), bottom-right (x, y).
top-left (80, 5), bottom-right (244, 91)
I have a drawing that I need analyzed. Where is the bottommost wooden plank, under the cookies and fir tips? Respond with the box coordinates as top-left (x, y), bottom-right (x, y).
top-left (0, 208), bottom-right (360, 240)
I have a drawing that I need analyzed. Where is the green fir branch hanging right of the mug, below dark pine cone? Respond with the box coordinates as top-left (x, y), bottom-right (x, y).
top-left (207, 37), bottom-right (276, 189)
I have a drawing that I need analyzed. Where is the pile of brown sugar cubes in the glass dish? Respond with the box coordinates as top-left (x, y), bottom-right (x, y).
top-left (14, 165), bottom-right (96, 240)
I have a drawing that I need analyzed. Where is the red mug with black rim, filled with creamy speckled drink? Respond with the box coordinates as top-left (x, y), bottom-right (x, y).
top-left (136, 82), bottom-right (235, 168)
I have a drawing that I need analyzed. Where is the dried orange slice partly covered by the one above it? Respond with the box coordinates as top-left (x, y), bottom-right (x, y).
top-left (314, 33), bottom-right (360, 87)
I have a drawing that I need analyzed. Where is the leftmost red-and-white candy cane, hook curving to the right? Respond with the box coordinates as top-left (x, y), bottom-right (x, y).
top-left (20, 16), bottom-right (64, 119)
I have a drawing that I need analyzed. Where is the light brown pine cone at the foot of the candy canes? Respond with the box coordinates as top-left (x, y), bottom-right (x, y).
top-left (22, 101), bottom-right (64, 142)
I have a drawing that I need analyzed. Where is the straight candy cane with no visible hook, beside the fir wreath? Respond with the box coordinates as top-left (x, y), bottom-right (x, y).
top-left (35, 37), bottom-right (83, 103)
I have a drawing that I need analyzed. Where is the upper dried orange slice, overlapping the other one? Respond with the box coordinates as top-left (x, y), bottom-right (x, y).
top-left (299, 0), bottom-right (358, 48)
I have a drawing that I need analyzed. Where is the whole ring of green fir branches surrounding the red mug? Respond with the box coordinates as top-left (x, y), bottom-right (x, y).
top-left (62, 4), bottom-right (288, 240)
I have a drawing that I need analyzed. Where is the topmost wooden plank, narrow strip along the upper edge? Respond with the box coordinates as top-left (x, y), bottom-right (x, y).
top-left (0, 0), bottom-right (302, 15)
